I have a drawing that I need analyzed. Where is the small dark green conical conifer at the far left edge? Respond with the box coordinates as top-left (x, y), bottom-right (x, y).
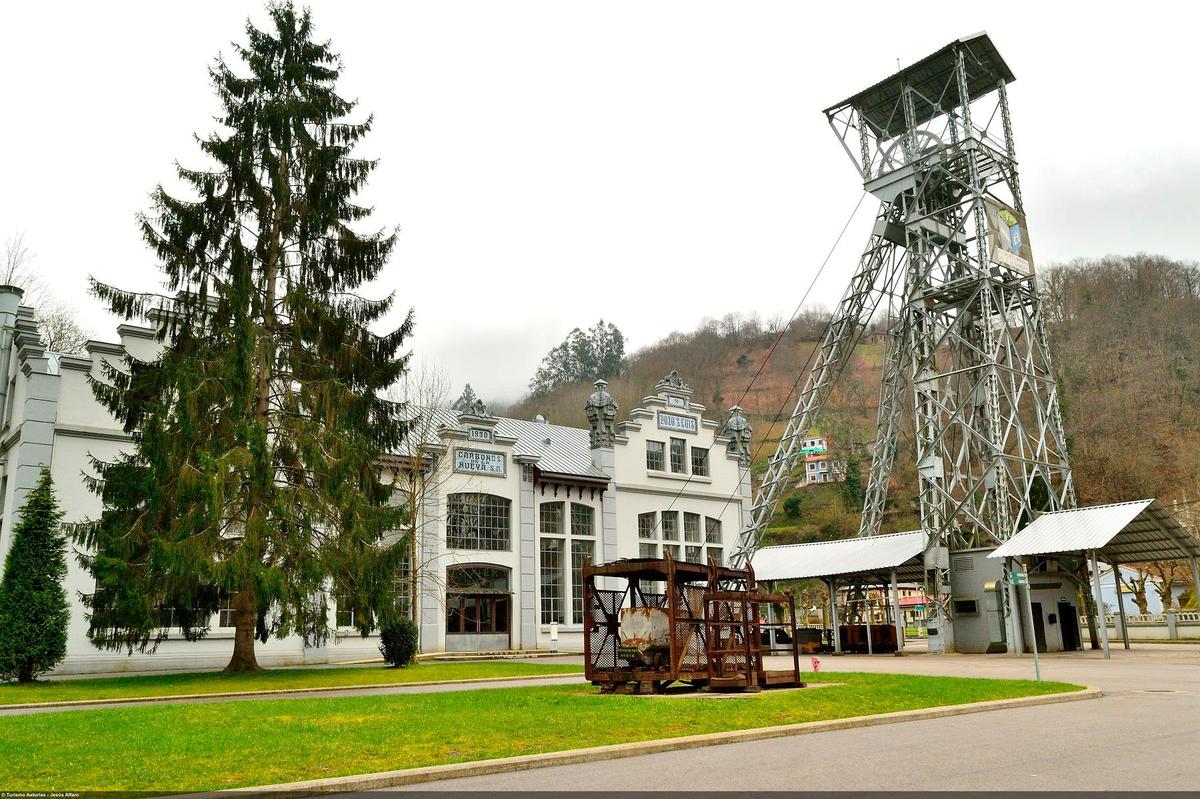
top-left (0, 469), bottom-right (71, 683)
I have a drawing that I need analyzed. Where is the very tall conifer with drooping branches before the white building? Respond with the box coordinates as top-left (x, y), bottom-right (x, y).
top-left (74, 4), bottom-right (412, 671)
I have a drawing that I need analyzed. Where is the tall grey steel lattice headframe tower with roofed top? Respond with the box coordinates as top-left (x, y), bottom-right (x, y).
top-left (734, 34), bottom-right (1075, 652)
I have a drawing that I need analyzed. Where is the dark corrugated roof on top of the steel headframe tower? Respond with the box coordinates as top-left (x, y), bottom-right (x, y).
top-left (826, 31), bottom-right (1016, 136)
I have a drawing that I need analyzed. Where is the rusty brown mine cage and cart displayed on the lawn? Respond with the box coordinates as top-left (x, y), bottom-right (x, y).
top-left (583, 557), bottom-right (804, 693)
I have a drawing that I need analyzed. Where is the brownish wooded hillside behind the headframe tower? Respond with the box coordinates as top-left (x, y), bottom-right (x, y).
top-left (504, 256), bottom-right (1200, 542)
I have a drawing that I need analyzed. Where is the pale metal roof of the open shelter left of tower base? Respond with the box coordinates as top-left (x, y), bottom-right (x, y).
top-left (750, 530), bottom-right (925, 581)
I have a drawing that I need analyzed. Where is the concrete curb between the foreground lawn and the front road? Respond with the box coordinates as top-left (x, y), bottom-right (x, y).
top-left (192, 689), bottom-right (1104, 799)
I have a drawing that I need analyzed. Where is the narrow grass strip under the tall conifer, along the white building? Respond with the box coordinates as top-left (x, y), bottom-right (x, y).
top-left (0, 661), bottom-right (583, 705)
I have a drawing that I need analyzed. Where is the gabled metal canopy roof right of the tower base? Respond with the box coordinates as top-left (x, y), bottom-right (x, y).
top-left (988, 499), bottom-right (1200, 564)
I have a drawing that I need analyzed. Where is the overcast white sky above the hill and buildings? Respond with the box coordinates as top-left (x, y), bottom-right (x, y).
top-left (0, 0), bottom-right (1200, 400)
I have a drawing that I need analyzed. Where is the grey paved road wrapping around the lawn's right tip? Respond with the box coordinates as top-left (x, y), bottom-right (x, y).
top-left (374, 644), bottom-right (1200, 791)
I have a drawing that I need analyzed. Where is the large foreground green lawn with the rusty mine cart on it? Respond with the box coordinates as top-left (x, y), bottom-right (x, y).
top-left (0, 673), bottom-right (1079, 791)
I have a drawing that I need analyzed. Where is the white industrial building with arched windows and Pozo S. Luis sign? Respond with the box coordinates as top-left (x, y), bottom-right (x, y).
top-left (0, 287), bottom-right (751, 673)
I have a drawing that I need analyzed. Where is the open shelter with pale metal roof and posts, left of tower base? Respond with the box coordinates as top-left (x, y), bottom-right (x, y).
top-left (751, 530), bottom-right (928, 653)
